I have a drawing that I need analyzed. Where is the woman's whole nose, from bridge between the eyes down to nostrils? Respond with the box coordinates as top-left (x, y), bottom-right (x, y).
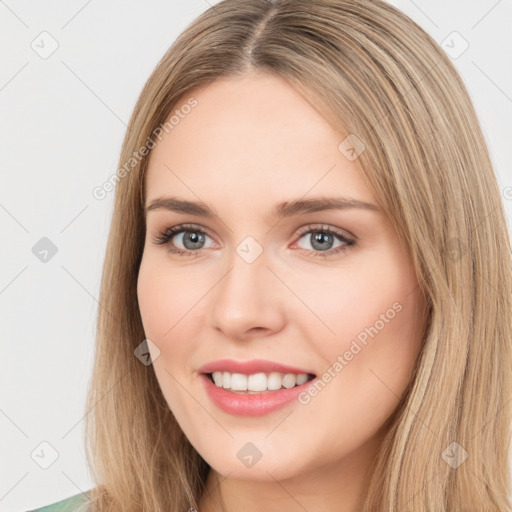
top-left (210, 237), bottom-right (284, 338)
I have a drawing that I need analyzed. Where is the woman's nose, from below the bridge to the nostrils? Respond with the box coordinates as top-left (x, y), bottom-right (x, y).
top-left (208, 243), bottom-right (286, 340)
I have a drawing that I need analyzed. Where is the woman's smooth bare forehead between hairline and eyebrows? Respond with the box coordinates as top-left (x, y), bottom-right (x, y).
top-left (146, 73), bottom-right (373, 212)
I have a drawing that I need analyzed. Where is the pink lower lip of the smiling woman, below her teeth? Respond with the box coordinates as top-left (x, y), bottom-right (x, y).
top-left (200, 374), bottom-right (314, 416)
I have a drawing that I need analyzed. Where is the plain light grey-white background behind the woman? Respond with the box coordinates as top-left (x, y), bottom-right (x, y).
top-left (0, 0), bottom-right (512, 512)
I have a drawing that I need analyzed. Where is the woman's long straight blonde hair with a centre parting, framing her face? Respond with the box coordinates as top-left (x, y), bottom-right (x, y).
top-left (86, 0), bottom-right (512, 512)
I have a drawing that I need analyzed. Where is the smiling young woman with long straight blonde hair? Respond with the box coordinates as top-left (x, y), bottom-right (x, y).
top-left (31, 0), bottom-right (512, 512)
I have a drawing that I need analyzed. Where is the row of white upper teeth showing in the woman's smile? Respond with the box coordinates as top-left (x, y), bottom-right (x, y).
top-left (212, 372), bottom-right (308, 392)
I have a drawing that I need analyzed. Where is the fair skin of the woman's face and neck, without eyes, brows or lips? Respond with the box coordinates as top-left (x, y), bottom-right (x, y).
top-left (138, 72), bottom-right (425, 512)
